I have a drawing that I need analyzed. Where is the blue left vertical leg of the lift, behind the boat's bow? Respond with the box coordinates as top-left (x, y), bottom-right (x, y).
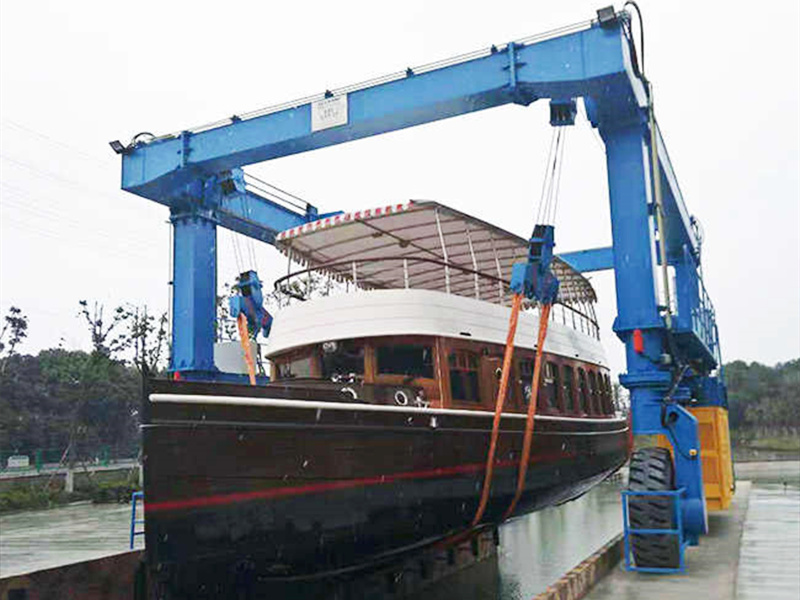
top-left (170, 210), bottom-right (217, 379)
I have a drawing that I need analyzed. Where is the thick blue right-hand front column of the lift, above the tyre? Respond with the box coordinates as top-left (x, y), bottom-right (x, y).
top-left (600, 119), bottom-right (708, 544)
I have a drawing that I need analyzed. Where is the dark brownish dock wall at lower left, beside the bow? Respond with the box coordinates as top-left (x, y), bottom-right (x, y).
top-left (0, 550), bottom-right (142, 600)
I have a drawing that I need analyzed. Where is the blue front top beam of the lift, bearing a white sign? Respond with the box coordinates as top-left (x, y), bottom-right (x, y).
top-left (122, 18), bottom-right (646, 204)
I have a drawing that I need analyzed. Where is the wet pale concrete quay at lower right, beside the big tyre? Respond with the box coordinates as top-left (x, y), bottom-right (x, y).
top-left (587, 461), bottom-right (800, 600)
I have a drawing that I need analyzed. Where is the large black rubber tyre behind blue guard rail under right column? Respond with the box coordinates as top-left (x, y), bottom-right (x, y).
top-left (628, 448), bottom-right (680, 569)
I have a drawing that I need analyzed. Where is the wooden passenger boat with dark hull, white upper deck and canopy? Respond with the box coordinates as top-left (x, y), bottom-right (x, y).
top-left (143, 202), bottom-right (628, 586)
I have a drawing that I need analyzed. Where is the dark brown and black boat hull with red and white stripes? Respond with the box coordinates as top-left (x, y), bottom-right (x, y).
top-left (143, 382), bottom-right (627, 582)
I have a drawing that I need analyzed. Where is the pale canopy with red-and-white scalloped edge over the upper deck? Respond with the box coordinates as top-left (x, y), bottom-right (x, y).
top-left (276, 201), bottom-right (596, 312)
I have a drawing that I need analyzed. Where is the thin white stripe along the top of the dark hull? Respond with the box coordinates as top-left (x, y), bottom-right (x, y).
top-left (150, 394), bottom-right (625, 424)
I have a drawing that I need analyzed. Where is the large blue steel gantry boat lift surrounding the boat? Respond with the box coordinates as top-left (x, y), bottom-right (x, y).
top-left (111, 7), bottom-right (733, 569)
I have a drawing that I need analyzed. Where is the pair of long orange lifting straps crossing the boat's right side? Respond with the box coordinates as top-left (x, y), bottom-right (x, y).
top-left (472, 294), bottom-right (551, 527)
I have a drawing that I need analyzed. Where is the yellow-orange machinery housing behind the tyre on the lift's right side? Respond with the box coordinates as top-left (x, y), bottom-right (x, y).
top-left (658, 406), bottom-right (734, 511)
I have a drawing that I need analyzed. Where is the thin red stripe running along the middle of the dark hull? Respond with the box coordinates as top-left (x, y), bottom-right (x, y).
top-left (145, 453), bottom-right (574, 512)
